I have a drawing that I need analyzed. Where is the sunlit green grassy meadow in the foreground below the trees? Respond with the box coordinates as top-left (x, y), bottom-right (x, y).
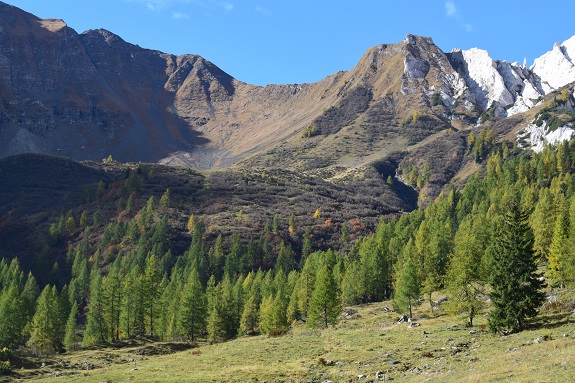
top-left (7, 302), bottom-right (575, 383)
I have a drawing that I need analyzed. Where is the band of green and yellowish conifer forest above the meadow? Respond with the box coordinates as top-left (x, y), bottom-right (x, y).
top-left (0, 143), bottom-right (575, 353)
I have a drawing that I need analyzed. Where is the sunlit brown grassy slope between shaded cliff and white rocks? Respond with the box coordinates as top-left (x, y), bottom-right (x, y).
top-left (162, 36), bottom-right (472, 178)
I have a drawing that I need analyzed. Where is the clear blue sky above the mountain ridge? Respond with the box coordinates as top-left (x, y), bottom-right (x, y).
top-left (6, 0), bottom-right (575, 85)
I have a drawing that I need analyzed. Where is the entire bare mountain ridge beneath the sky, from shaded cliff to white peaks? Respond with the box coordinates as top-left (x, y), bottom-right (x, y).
top-left (0, 2), bottom-right (575, 170)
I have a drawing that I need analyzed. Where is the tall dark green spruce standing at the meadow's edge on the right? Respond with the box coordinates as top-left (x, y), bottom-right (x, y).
top-left (488, 191), bottom-right (544, 332)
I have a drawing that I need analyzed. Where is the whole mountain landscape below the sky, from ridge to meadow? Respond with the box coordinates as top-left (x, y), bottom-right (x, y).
top-left (0, 2), bottom-right (575, 382)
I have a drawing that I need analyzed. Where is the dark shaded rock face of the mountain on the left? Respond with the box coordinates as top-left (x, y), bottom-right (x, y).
top-left (0, 3), bottom-right (209, 160)
